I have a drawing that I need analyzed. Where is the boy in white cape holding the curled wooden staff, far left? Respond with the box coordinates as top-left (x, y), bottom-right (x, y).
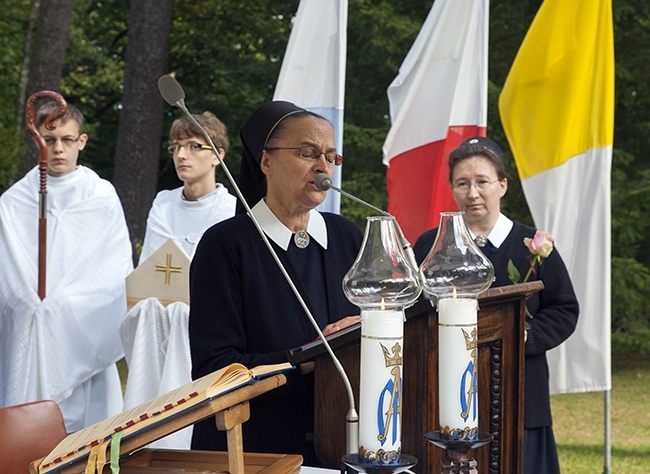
top-left (0, 100), bottom-right (133, 432)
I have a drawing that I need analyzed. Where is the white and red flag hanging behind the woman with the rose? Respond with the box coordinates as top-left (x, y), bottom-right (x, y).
top-left (383, 0), bottom-right (489, 242)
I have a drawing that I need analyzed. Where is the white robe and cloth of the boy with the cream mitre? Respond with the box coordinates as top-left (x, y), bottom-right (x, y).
top-left (120, 184), bottom-right (237, 449)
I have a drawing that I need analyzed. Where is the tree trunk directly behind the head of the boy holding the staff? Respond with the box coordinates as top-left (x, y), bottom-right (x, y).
top-left (17, 0), bottom-right (74, 175)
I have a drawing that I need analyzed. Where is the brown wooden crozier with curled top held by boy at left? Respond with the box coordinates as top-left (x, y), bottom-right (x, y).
top-left (25, 91), bottom-right (68, 300)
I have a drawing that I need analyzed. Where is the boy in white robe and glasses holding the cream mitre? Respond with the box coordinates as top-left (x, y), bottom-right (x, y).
top-left (120, 112), bottom-right (237, 449)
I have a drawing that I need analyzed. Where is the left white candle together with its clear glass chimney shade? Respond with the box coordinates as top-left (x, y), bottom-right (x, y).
top-left (343, 216), bottom-right (422, 465)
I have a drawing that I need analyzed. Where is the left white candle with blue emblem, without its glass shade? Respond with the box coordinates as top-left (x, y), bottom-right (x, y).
top-left (359, 310), bottom-right (404, 464)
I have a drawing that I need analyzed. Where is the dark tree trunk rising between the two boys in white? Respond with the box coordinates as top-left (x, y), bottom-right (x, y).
top-left (113, 0), bottom-right (173, 260)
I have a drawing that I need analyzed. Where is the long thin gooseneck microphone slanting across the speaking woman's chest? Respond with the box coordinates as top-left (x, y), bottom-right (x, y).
top-left (158, 74), bottom-right (359, 454)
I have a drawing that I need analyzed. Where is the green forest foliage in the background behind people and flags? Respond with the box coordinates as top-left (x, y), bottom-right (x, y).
top-left (0, 0), bottom-right (650, 331)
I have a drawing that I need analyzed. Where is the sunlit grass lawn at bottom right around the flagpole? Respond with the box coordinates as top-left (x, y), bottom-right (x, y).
top-left (551, 356), bottom-right (650, 474)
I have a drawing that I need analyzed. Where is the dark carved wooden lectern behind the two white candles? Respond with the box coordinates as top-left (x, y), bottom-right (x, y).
top-left (291, 281), bottom-right (543, 474)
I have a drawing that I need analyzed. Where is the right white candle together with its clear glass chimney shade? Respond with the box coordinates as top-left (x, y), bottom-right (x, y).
top-left (420, 212), bottom-right (494, 441)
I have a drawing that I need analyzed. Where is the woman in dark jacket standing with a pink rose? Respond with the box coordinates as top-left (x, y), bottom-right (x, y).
top-left (414, 137), bottom-right (579, 474)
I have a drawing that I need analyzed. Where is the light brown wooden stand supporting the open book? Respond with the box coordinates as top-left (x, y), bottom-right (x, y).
top-left (29, 374), bottom-right (302, 474)
